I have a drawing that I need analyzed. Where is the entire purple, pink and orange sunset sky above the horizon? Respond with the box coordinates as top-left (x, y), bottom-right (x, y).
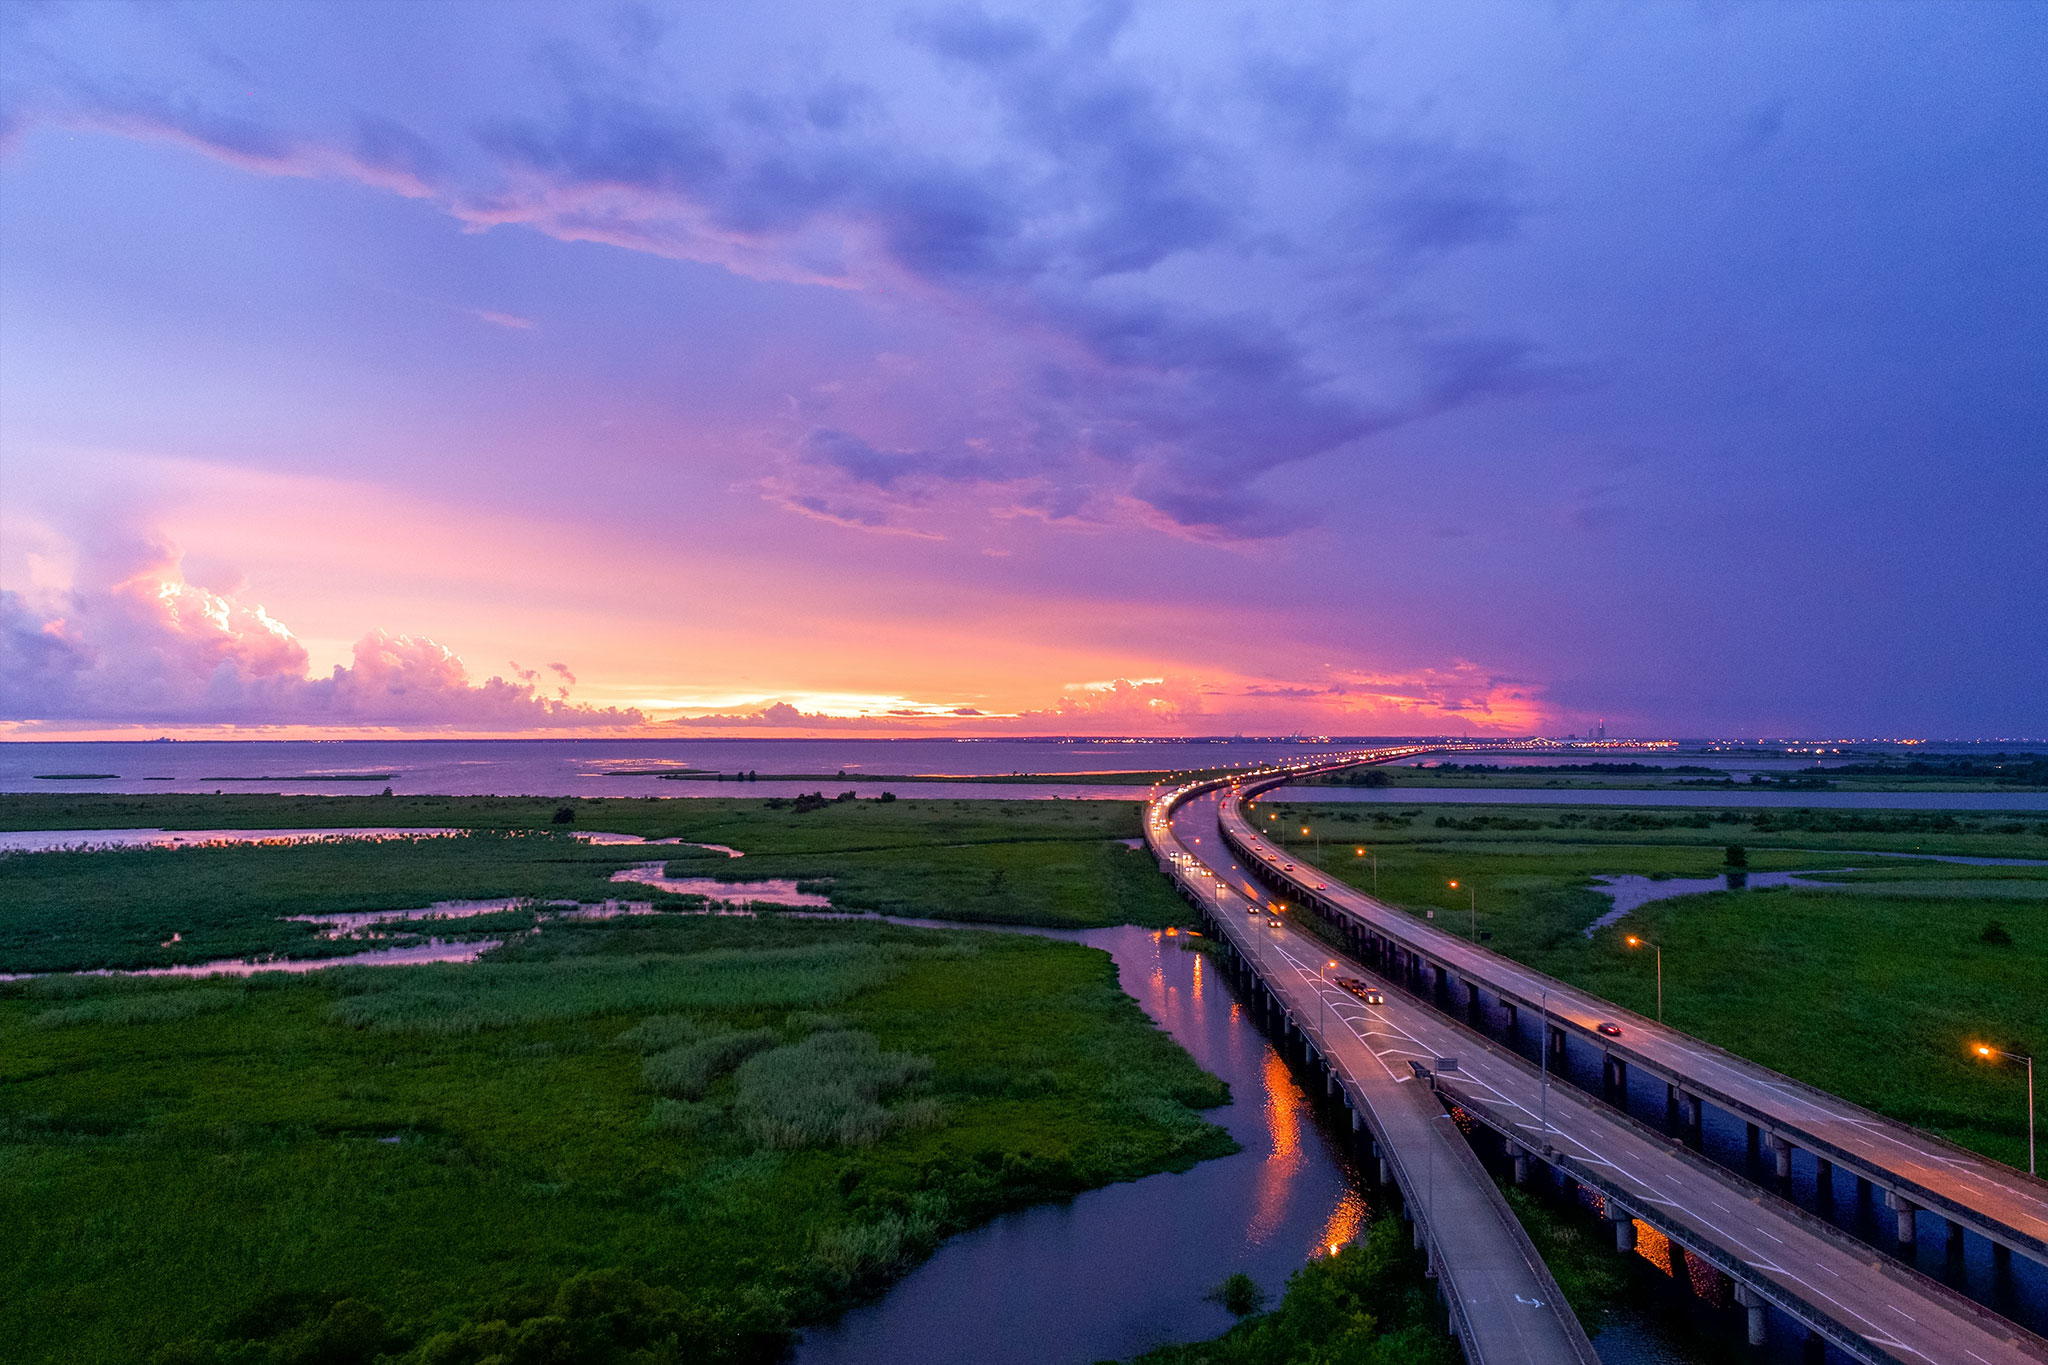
top-left (0, 0), bottom-right (2048, 739)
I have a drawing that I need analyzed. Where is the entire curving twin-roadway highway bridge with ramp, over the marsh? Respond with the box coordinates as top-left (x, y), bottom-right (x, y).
top-left (1147, 745), bottom-right (2048, 1365)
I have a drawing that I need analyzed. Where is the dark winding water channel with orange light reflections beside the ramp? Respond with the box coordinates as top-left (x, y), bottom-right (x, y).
top-left (791, 921), bottom-right (1698, 1365)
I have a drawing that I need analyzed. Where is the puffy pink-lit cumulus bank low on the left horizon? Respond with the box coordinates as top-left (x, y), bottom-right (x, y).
top-left (0, 546), bottom-right (645, 731)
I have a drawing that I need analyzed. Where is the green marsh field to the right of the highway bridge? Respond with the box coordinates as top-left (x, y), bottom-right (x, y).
top-left (1274, 802), bottom-right (2048, 1166)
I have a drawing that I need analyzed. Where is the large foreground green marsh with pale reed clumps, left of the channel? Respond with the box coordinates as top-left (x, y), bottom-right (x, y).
top-left (0, 917), bottom-right (1233, 1365)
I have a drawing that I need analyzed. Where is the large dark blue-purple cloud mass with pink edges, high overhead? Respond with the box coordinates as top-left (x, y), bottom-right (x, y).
top-left (0, 4), bottom-right (1538, 540)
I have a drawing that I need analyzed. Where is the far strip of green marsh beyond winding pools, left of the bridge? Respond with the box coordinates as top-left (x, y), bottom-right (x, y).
top-left (0, 796), bottom-right (1182, 972)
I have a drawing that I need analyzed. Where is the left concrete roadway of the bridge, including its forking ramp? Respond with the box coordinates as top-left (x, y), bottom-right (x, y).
top-left (1149, 757), bottom-right (2048, 1365)
